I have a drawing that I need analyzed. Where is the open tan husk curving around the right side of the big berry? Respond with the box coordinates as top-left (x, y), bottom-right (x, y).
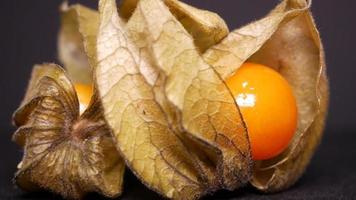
top-left (204, 0), bottom-right (329, 192)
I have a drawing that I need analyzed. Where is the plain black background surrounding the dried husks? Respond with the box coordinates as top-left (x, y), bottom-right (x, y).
top-left (0, 0), bottom-right (356, 199)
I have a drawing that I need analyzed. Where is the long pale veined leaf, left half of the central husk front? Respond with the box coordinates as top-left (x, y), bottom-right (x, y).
top-left (96, 0), bottom-right (210, 199)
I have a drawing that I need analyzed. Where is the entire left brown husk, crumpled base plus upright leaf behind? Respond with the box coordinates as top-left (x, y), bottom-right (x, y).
top-left (13, 4), bottom-right (125, 199)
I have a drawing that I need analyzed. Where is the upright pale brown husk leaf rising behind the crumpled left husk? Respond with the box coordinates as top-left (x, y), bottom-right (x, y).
top-left (58, 2), bottom-right (99, 84)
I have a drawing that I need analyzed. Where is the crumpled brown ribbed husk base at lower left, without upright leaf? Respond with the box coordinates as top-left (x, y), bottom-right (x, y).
top-left (13, 64), bottom-right (124, 199)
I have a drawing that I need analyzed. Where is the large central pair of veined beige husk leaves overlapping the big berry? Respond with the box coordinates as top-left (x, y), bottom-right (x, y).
top-left (96, 0), bottom-right (251, 199)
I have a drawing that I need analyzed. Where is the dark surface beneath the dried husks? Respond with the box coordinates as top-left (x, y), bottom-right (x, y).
top-left (0, 131), bottom-right (356, 200)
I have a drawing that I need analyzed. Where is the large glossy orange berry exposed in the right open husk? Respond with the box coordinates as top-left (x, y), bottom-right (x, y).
top-left (226, 63), bottom-right (298, 160)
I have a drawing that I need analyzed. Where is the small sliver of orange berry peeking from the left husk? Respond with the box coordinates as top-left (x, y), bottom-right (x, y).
top-left (74, 83), bottom-right (93, 114)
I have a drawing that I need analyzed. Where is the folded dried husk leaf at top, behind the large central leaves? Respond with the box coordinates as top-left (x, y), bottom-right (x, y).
top-left (120, 0), bottom-right (229, 52)
